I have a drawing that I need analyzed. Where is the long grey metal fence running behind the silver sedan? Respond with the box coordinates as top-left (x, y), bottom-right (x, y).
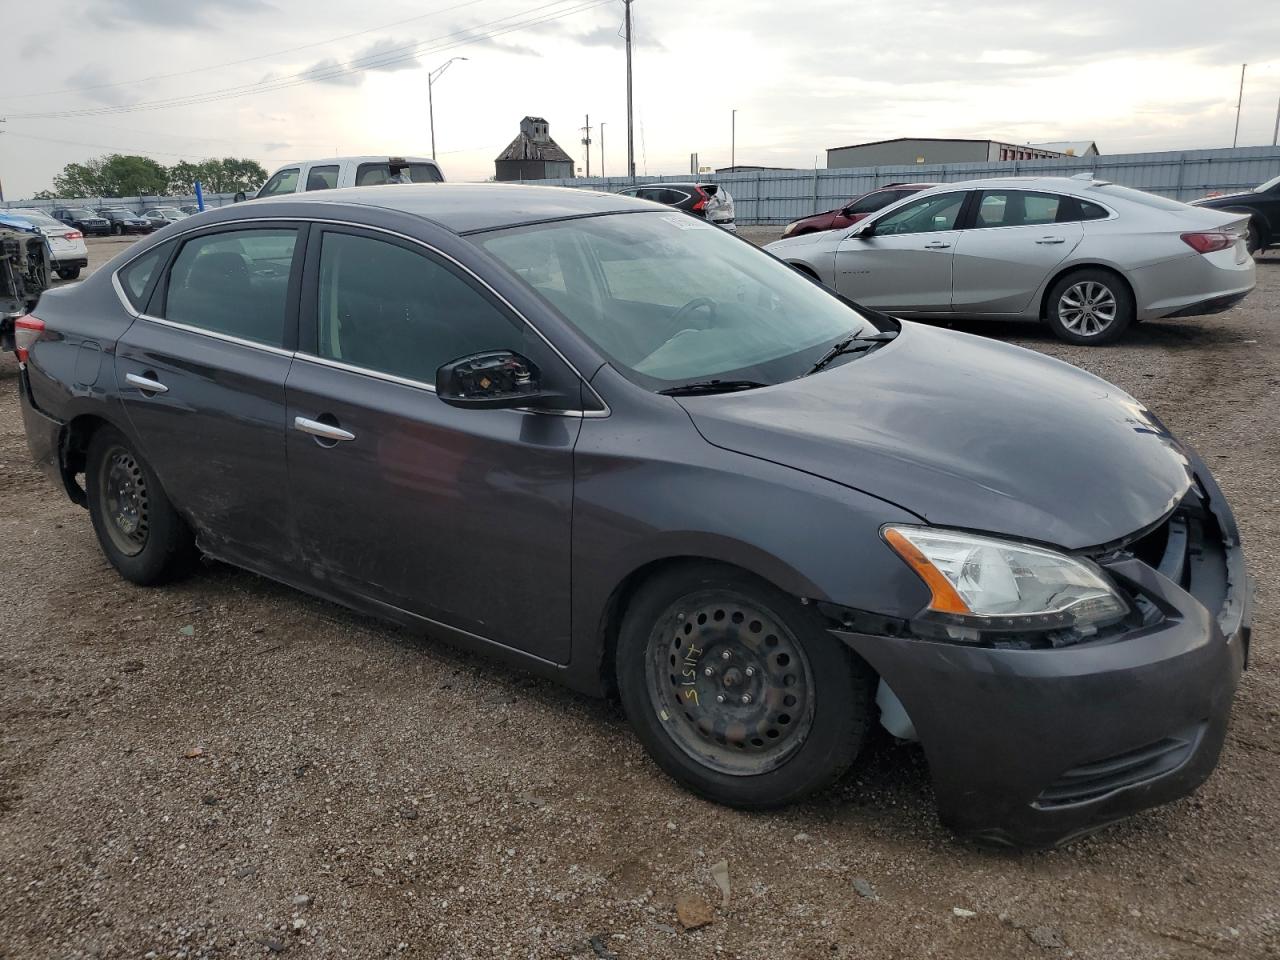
top-left (517, 147), bottom-right (1280, 225)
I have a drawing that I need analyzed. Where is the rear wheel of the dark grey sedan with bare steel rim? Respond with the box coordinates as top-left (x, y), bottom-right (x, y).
top-left (84, 426), bottom-right (196, 586)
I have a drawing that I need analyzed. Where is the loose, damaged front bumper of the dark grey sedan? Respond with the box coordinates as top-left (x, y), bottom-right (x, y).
top-left (832, 462), bottom-right (1252, 847)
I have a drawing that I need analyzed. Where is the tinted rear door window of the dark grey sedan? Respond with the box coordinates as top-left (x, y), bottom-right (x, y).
top-left (164, 228), bottom-right (298, 347)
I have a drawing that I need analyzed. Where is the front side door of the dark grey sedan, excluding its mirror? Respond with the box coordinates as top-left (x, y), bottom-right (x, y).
top-left (287, 225), bottom-right (581, 662)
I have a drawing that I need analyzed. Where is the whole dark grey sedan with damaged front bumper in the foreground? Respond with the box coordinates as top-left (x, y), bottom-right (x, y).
top-left (17, 184), bottom-right (1251, 845)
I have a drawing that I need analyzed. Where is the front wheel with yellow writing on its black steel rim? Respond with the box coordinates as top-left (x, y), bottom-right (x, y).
top-left (616, 562), bottom-right (876, 810)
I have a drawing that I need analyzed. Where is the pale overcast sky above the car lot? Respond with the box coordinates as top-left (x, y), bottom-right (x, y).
top-left (0, 0), bottom-right (1280, 198)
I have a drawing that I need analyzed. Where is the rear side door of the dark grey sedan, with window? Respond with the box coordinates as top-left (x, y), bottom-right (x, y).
top-left (115, 223), bottom-right (302, 567)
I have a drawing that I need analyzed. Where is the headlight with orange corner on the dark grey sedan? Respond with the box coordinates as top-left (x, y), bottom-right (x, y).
top-left (883, 526), bottom-right (1129, 639)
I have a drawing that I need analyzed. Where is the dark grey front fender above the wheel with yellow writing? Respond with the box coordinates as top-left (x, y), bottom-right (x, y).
top-left (571, 366), bottom-right (928, 689)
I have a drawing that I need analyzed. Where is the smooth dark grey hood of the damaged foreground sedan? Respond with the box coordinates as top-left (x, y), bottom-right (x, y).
top-left (680, 323), bottom-right (1192, 549)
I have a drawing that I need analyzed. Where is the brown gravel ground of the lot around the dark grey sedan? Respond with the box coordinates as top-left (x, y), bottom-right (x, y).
top-left (0, 230), bottom-right (1280, 960)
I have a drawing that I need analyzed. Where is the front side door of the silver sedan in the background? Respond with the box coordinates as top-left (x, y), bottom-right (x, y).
top-left (836, 191), bottom-right (968, 314)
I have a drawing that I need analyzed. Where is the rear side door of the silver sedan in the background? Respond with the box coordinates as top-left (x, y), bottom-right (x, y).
top-left (951, 189), bottom-right (1084, 314)
